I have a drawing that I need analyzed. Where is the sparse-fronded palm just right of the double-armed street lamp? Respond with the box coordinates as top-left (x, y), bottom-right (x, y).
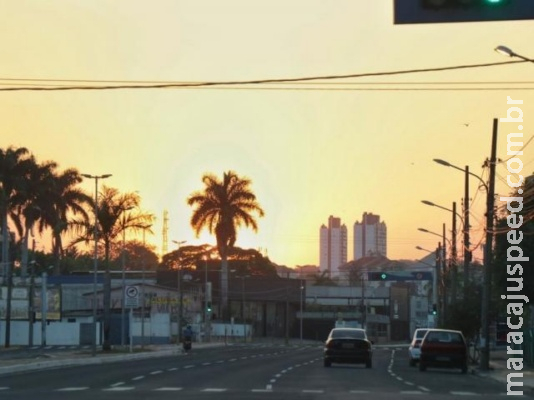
top-left (73, 186), bottom-right (154, 350)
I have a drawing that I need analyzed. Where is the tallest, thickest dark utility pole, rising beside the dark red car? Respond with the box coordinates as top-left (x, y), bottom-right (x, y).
top-left (480, 118), bottom-right (498, 371)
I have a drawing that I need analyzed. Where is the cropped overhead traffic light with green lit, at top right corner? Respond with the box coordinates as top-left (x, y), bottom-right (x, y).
top-left (394, 0), bottom-right (534, 25)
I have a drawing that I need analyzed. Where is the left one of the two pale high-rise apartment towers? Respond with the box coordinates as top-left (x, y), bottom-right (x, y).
top-left (319, 216), bottom-right (347, 276)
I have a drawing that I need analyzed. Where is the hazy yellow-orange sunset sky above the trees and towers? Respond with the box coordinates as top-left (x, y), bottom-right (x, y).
top-left (0, 0), bottom-right (534, 267)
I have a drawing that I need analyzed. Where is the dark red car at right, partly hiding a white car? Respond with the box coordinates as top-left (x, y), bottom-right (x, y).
top-left (419, 329), bottom-right (467, 374)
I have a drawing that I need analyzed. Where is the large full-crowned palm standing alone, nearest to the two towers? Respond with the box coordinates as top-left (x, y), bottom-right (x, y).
top-left (187, 171), bottom-right (264, 319)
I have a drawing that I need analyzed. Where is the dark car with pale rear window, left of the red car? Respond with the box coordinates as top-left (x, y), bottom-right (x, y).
top-left (324, 328), bottom-right (373, 368)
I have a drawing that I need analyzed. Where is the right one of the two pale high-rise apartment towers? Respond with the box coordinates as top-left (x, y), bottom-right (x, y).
top-left (354, 213), bottom-right (387, 260)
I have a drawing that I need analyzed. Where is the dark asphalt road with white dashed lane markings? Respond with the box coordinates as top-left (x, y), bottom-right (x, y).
top-left (0, 344), bottom-right (524, 400)
